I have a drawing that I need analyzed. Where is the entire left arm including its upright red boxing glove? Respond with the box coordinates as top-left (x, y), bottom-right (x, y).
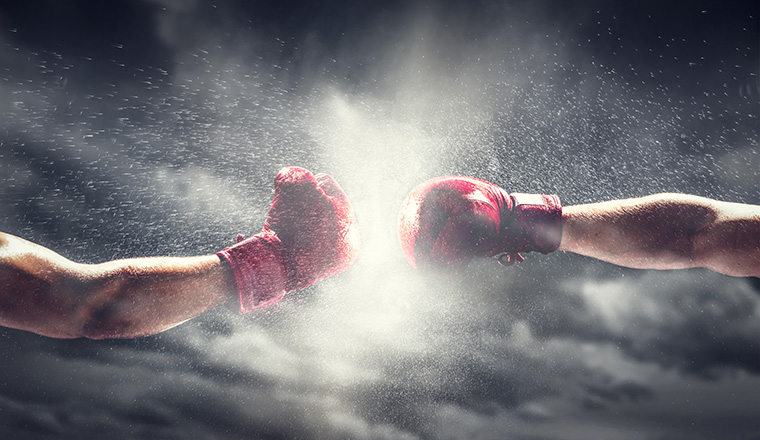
top-left (0, 167), bottom-right (359, 339)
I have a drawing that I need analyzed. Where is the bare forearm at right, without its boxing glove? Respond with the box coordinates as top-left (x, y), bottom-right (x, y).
top-left (560, 194), bottom-right (760, 276)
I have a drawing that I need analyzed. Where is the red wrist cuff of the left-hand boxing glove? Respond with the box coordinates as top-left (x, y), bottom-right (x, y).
top-left (216, 234), bottom-right (286, 313)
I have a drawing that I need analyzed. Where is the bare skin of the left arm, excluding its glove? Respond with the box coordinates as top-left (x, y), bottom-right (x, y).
top-left (0, 233), bottom-right (236, 339)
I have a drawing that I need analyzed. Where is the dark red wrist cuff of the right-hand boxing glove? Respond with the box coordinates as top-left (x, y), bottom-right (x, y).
top-left (508, 193), bottom-right (562, 254)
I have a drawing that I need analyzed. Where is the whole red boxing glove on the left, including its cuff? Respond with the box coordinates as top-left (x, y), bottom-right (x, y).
top-left (217, 167), bottom-right (359, 313)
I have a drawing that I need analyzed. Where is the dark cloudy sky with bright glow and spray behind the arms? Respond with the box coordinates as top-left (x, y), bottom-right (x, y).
top-left (0, 0), bottom-right (760, 440)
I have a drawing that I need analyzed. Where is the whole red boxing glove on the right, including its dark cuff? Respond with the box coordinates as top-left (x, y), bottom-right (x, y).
top-left (398, 176), bottom-right (562, 270)
